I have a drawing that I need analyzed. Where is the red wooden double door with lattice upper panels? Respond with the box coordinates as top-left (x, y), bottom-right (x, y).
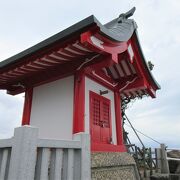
top-left (90, 91), bottom-right (112, 144)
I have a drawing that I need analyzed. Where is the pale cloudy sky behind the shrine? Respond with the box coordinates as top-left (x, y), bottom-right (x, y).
top-left (0, 0), bottom-right (180, 148)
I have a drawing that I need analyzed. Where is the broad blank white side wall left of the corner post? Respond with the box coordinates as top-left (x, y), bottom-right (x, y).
top-left (30, 76), bottom-right (74, 139)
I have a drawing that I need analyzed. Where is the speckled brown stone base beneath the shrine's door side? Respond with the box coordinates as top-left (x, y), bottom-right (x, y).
top-left (91, 152), bottom-right (140, 180)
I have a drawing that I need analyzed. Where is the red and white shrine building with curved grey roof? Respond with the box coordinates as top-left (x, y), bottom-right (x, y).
top-left (0, 9), bottom-right (160, 152)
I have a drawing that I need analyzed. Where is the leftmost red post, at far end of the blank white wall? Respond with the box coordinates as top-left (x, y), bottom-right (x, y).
top-left (22, 88), bottom-right (33, 126)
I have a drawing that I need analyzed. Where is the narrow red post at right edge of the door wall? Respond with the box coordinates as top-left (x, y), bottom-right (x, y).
top-left (114, 91), bottom-right (123, 145)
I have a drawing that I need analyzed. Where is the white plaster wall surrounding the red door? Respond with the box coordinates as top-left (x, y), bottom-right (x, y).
top-left (85, 77), bottom-right (117, 145)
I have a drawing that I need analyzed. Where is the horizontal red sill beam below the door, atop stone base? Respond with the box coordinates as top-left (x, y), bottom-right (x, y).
top-left (91, 143), bottom-right (127, 152)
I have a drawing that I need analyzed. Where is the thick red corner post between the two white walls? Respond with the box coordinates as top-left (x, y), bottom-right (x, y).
top-left (73, 71), bottom-right (85, 134)
